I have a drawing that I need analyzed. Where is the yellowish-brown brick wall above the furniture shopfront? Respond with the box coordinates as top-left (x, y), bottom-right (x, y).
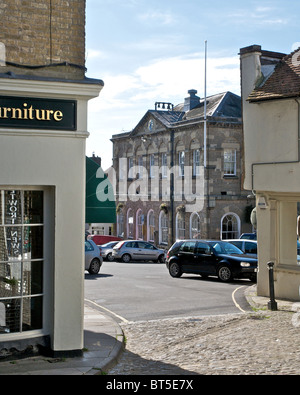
top-left (0, 0), bottom-right (85, 78)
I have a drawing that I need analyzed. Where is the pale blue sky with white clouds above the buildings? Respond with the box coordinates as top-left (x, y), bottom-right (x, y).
top-left (86, 0), bottom-right (300, 170)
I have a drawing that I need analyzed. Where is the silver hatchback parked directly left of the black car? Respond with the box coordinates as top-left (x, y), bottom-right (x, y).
top-left (112, 240), bottom-right (165, 263)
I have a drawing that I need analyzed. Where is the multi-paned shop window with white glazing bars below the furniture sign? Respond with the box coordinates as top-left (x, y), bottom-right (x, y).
top-left (0, 190), bottom-right (44, 333)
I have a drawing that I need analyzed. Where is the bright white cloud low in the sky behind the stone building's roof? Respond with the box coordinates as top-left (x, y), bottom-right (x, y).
top-left (87, 53), bottom-right (240, 167)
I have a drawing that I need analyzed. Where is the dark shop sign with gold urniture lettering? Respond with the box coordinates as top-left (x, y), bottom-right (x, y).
top-left (0, 96), bottom-right (76, 130)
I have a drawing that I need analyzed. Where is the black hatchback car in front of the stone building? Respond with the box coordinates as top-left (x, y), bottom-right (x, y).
top-left (166, 240), bottom-right (257, 282)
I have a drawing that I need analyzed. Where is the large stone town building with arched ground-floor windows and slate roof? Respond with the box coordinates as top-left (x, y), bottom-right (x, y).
top-left (111, 90), bottom-right (254, 248)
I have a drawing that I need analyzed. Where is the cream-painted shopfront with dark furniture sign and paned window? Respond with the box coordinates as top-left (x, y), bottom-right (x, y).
top-left (0, 73), bottom-right (103, 356)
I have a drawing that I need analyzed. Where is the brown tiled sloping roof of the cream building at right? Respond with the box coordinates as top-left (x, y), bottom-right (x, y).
top-left (248, 48), bottom-right (300, 102)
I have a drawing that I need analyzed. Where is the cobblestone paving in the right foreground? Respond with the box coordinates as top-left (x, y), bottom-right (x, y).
top-left (108, 311), bottom-right (300, 375)
